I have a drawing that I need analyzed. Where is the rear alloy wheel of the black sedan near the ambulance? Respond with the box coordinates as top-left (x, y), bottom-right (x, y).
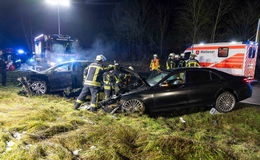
top-left (215, 92), bottom-right (236, 113)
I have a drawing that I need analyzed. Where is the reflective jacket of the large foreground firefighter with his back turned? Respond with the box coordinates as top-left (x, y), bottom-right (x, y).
top-left (84, 62), bottom-right (113, 87)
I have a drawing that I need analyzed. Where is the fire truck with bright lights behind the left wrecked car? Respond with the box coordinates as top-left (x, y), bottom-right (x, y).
top-left (34, 34), bottom-right (80, 66)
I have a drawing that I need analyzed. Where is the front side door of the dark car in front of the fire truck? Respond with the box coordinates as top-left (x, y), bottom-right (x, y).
top-left (48, 63), bottom-right (72, 91)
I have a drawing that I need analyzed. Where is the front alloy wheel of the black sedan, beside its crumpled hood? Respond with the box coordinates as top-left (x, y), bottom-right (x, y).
top-left (122, 99), bottom-right (145, 114)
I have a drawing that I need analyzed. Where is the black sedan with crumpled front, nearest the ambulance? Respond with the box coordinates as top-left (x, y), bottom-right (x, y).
top-left (118, 68), bottom-right (252, 113)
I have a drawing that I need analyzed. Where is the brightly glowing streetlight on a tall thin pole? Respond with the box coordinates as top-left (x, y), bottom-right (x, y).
top-left (45, 0), bottom-right (70, 35)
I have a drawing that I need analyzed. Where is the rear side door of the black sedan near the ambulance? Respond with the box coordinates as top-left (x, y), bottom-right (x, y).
top-left (186, 69), bottom-right (221, 106)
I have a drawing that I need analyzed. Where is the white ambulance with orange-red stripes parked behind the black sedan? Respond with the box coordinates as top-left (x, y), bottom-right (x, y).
top-left (184, 41), bottom-right (258, 79)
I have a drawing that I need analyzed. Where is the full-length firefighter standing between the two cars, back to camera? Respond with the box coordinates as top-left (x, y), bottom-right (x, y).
top-left (74, 55), bottom-right (114, 111)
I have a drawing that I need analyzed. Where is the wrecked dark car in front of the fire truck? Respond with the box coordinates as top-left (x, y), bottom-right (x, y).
top-left (19, 60), bottom-right (91, 95)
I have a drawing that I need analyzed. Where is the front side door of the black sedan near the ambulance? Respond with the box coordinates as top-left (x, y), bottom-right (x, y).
top-left (152, 72), bottom-right (189, 111)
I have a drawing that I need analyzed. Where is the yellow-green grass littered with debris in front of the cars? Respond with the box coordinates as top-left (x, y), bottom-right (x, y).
top-left (0, 86), bottom-right (260, 160)
